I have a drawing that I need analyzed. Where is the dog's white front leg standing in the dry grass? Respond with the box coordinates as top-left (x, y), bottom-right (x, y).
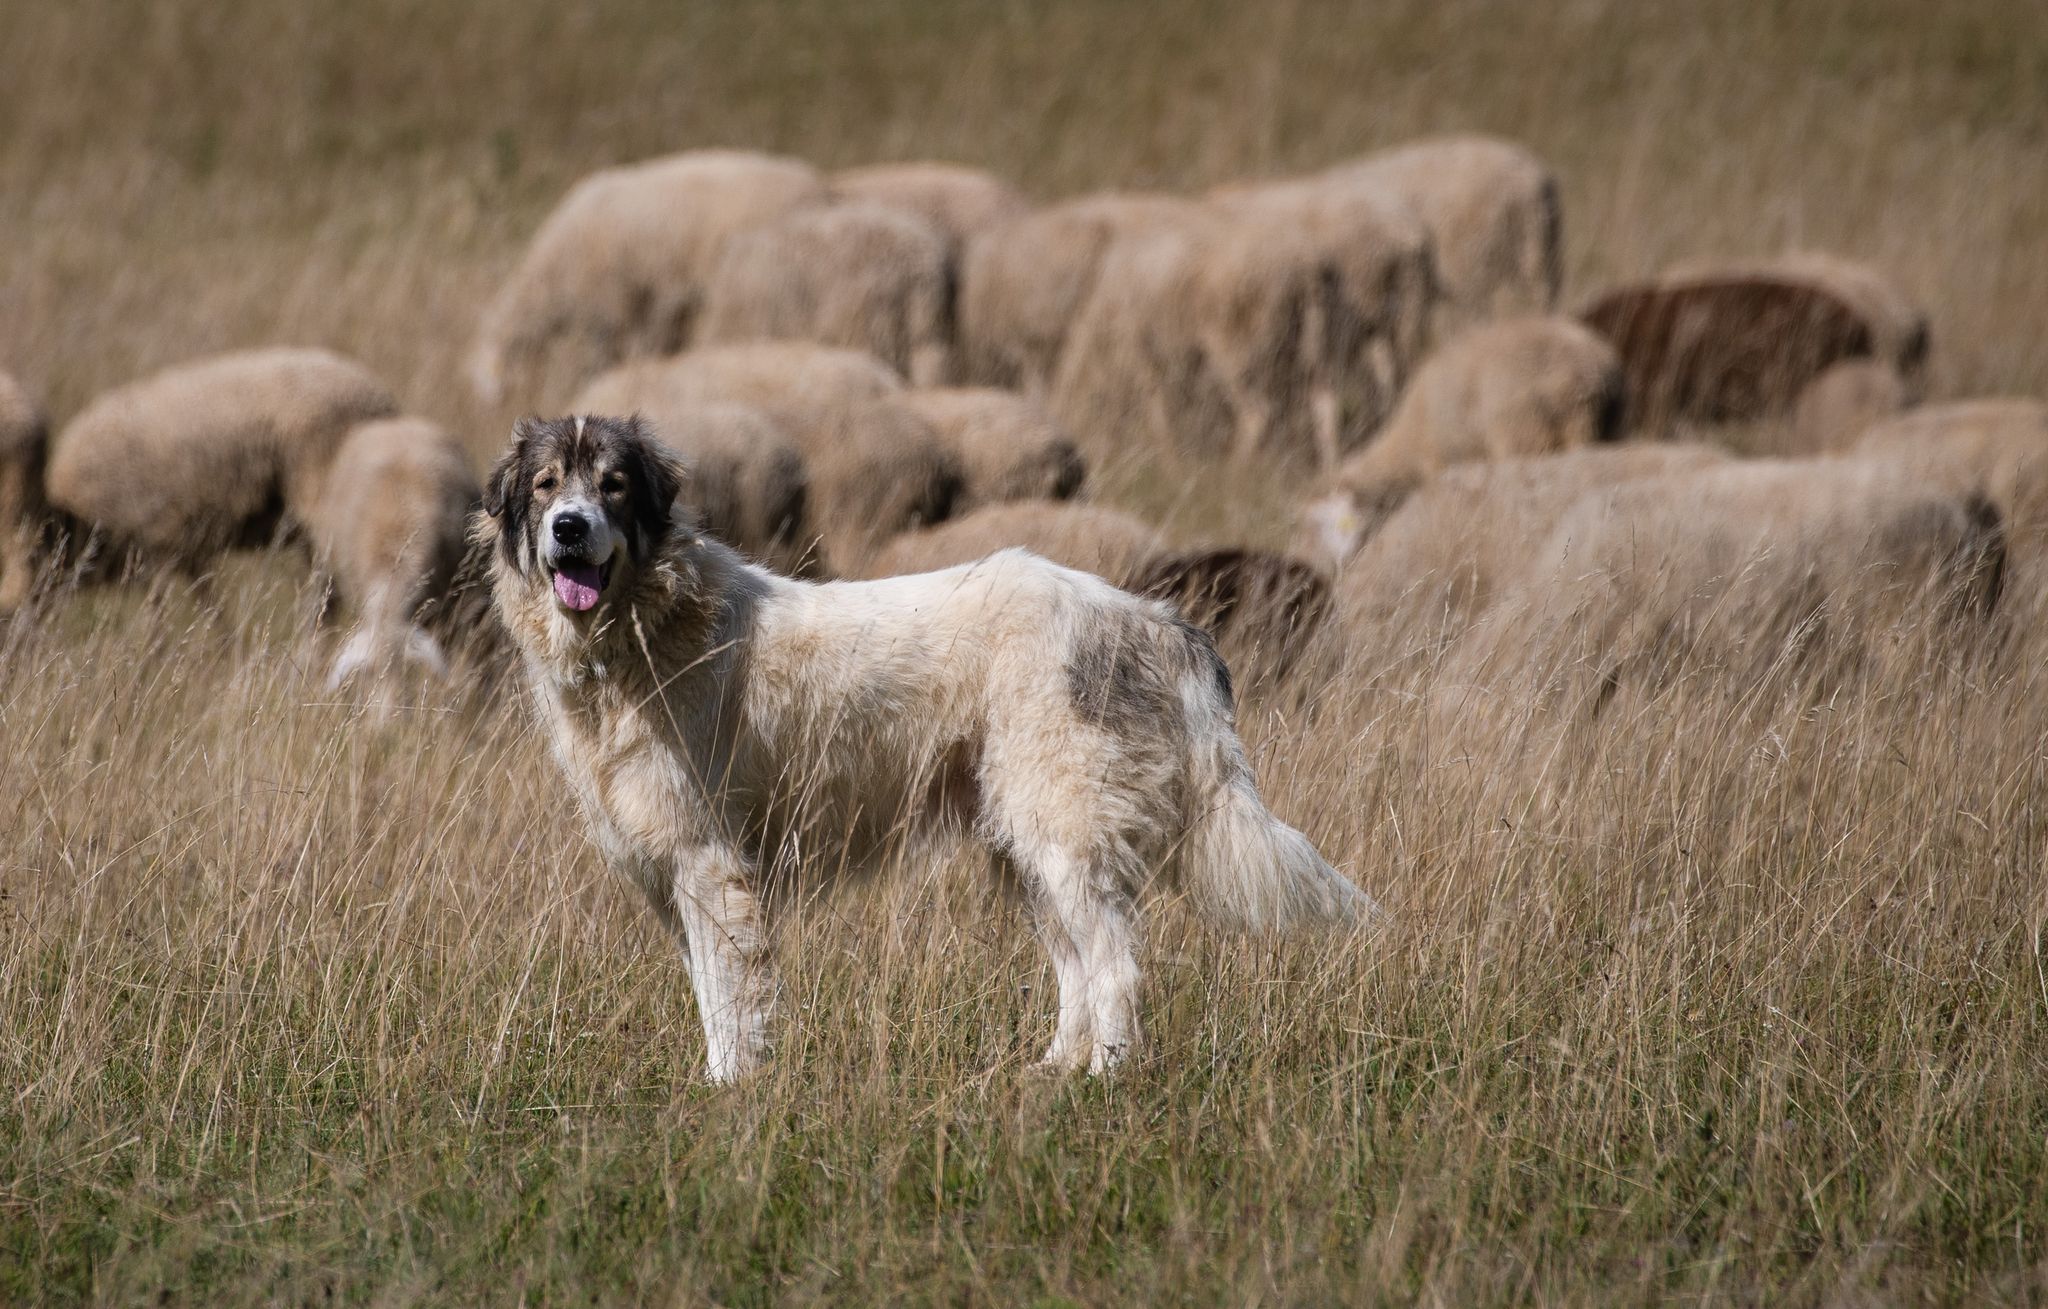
top-left (676, 844), bottom-right (776, 1082)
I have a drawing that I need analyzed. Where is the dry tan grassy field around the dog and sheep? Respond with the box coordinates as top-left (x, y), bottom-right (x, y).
top-left (0, 0), bottom-right (2048, 1305)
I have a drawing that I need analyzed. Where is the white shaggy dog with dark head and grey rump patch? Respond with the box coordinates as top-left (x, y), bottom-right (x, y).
top-left (475, 416), bottom-right (1374, 1082)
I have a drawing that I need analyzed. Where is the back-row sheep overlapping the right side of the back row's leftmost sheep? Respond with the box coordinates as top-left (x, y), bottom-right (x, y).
top-left (698, 201), bottom-right (954, 385)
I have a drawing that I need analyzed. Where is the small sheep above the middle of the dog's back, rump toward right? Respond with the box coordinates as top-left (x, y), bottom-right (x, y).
top-left (901, 387), bottom-right (1087, 512)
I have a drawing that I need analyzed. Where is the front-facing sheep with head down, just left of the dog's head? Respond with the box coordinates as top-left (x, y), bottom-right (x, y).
top-left (301, 418), bottom-right (481, 686)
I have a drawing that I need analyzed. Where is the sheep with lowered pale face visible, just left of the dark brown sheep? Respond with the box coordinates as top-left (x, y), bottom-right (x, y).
top-left (1305, 318), bottom-right (1622, 561)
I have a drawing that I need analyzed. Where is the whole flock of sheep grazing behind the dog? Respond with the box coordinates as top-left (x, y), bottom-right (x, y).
top-left (0, 137), bottom-right (2048, 716)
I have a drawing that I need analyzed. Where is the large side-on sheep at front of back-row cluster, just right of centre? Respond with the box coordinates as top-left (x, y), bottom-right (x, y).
top-left (1053, 209), bottom-right (1339, 463)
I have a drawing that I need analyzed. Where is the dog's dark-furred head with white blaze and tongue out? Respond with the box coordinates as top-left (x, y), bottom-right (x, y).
top-left (483, 416), bottom-right (684, 615)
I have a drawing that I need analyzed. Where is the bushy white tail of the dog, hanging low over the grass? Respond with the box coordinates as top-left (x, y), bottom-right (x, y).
top-left (1180, 622), bottom-right (1382, 932)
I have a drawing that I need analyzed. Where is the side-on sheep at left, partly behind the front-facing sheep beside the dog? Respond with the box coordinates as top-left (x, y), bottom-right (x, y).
top-left (47, 348), bottom-right (397, 567)
